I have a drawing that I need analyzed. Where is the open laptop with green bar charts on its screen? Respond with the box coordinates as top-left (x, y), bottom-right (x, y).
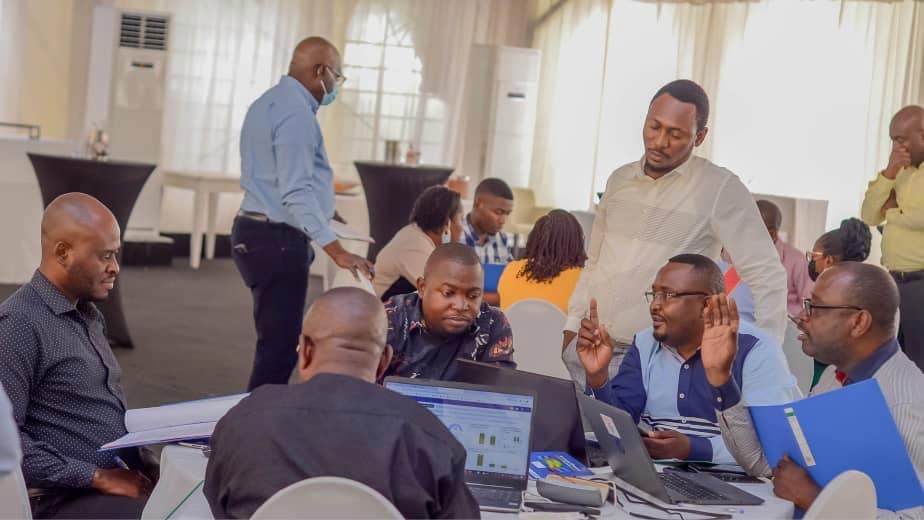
top-left (385, 377), bottom-right (536, 512)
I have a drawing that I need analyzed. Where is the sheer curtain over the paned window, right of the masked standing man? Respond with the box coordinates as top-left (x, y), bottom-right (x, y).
top-left (324, 0), bottom-right (528, 176)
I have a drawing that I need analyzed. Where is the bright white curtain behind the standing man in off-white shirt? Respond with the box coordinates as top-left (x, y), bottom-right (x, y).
top-left (531, 0), bottom-right (924, 236)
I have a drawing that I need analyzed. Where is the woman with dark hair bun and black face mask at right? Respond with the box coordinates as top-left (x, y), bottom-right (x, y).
top-left (805, 217), bottom-right (873, 388)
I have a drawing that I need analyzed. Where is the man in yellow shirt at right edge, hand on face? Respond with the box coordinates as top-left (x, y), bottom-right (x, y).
top-left (861, 105), bottom-right (924, 369)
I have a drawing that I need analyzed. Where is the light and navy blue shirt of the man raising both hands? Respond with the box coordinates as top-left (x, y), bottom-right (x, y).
top-left (592, 322), bottom-right (798, 464)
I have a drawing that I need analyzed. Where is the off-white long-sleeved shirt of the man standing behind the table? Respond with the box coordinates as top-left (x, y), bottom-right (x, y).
top-left (565, 156), bottom-right (787, 343)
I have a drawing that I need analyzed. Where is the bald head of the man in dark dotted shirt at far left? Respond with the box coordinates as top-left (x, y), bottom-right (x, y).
top-left (39, 193), bottom-right (121, 301)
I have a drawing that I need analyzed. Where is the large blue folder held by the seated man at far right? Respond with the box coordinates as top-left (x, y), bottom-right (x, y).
top-left (750, 379), bottom-right (924, 511)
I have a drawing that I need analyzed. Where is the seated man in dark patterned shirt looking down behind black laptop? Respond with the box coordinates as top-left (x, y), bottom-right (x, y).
top-left (383, 244), bottom-right (516, 379)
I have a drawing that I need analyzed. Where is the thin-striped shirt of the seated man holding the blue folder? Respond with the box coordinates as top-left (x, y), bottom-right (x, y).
top-left (716, 338), bottom-right (924, 520)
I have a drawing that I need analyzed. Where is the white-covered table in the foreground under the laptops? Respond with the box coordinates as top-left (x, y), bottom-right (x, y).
top-left (141, 445), bottom-right (793, 520)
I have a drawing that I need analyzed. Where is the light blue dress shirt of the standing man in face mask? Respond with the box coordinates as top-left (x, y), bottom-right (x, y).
top-left (241, 76), bottom-right (337, 247)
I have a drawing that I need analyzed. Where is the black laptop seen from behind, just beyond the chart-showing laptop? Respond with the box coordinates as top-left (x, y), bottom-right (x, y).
top-left (447, 359), bottom-right (587, 464)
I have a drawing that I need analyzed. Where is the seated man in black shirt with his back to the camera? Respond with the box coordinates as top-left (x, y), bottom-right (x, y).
top-left (204, 288), bottom-right (479, 518)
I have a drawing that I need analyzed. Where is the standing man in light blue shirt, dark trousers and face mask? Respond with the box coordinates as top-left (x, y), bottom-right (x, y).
top-left (231, 37), bottom-right (372, 390)
